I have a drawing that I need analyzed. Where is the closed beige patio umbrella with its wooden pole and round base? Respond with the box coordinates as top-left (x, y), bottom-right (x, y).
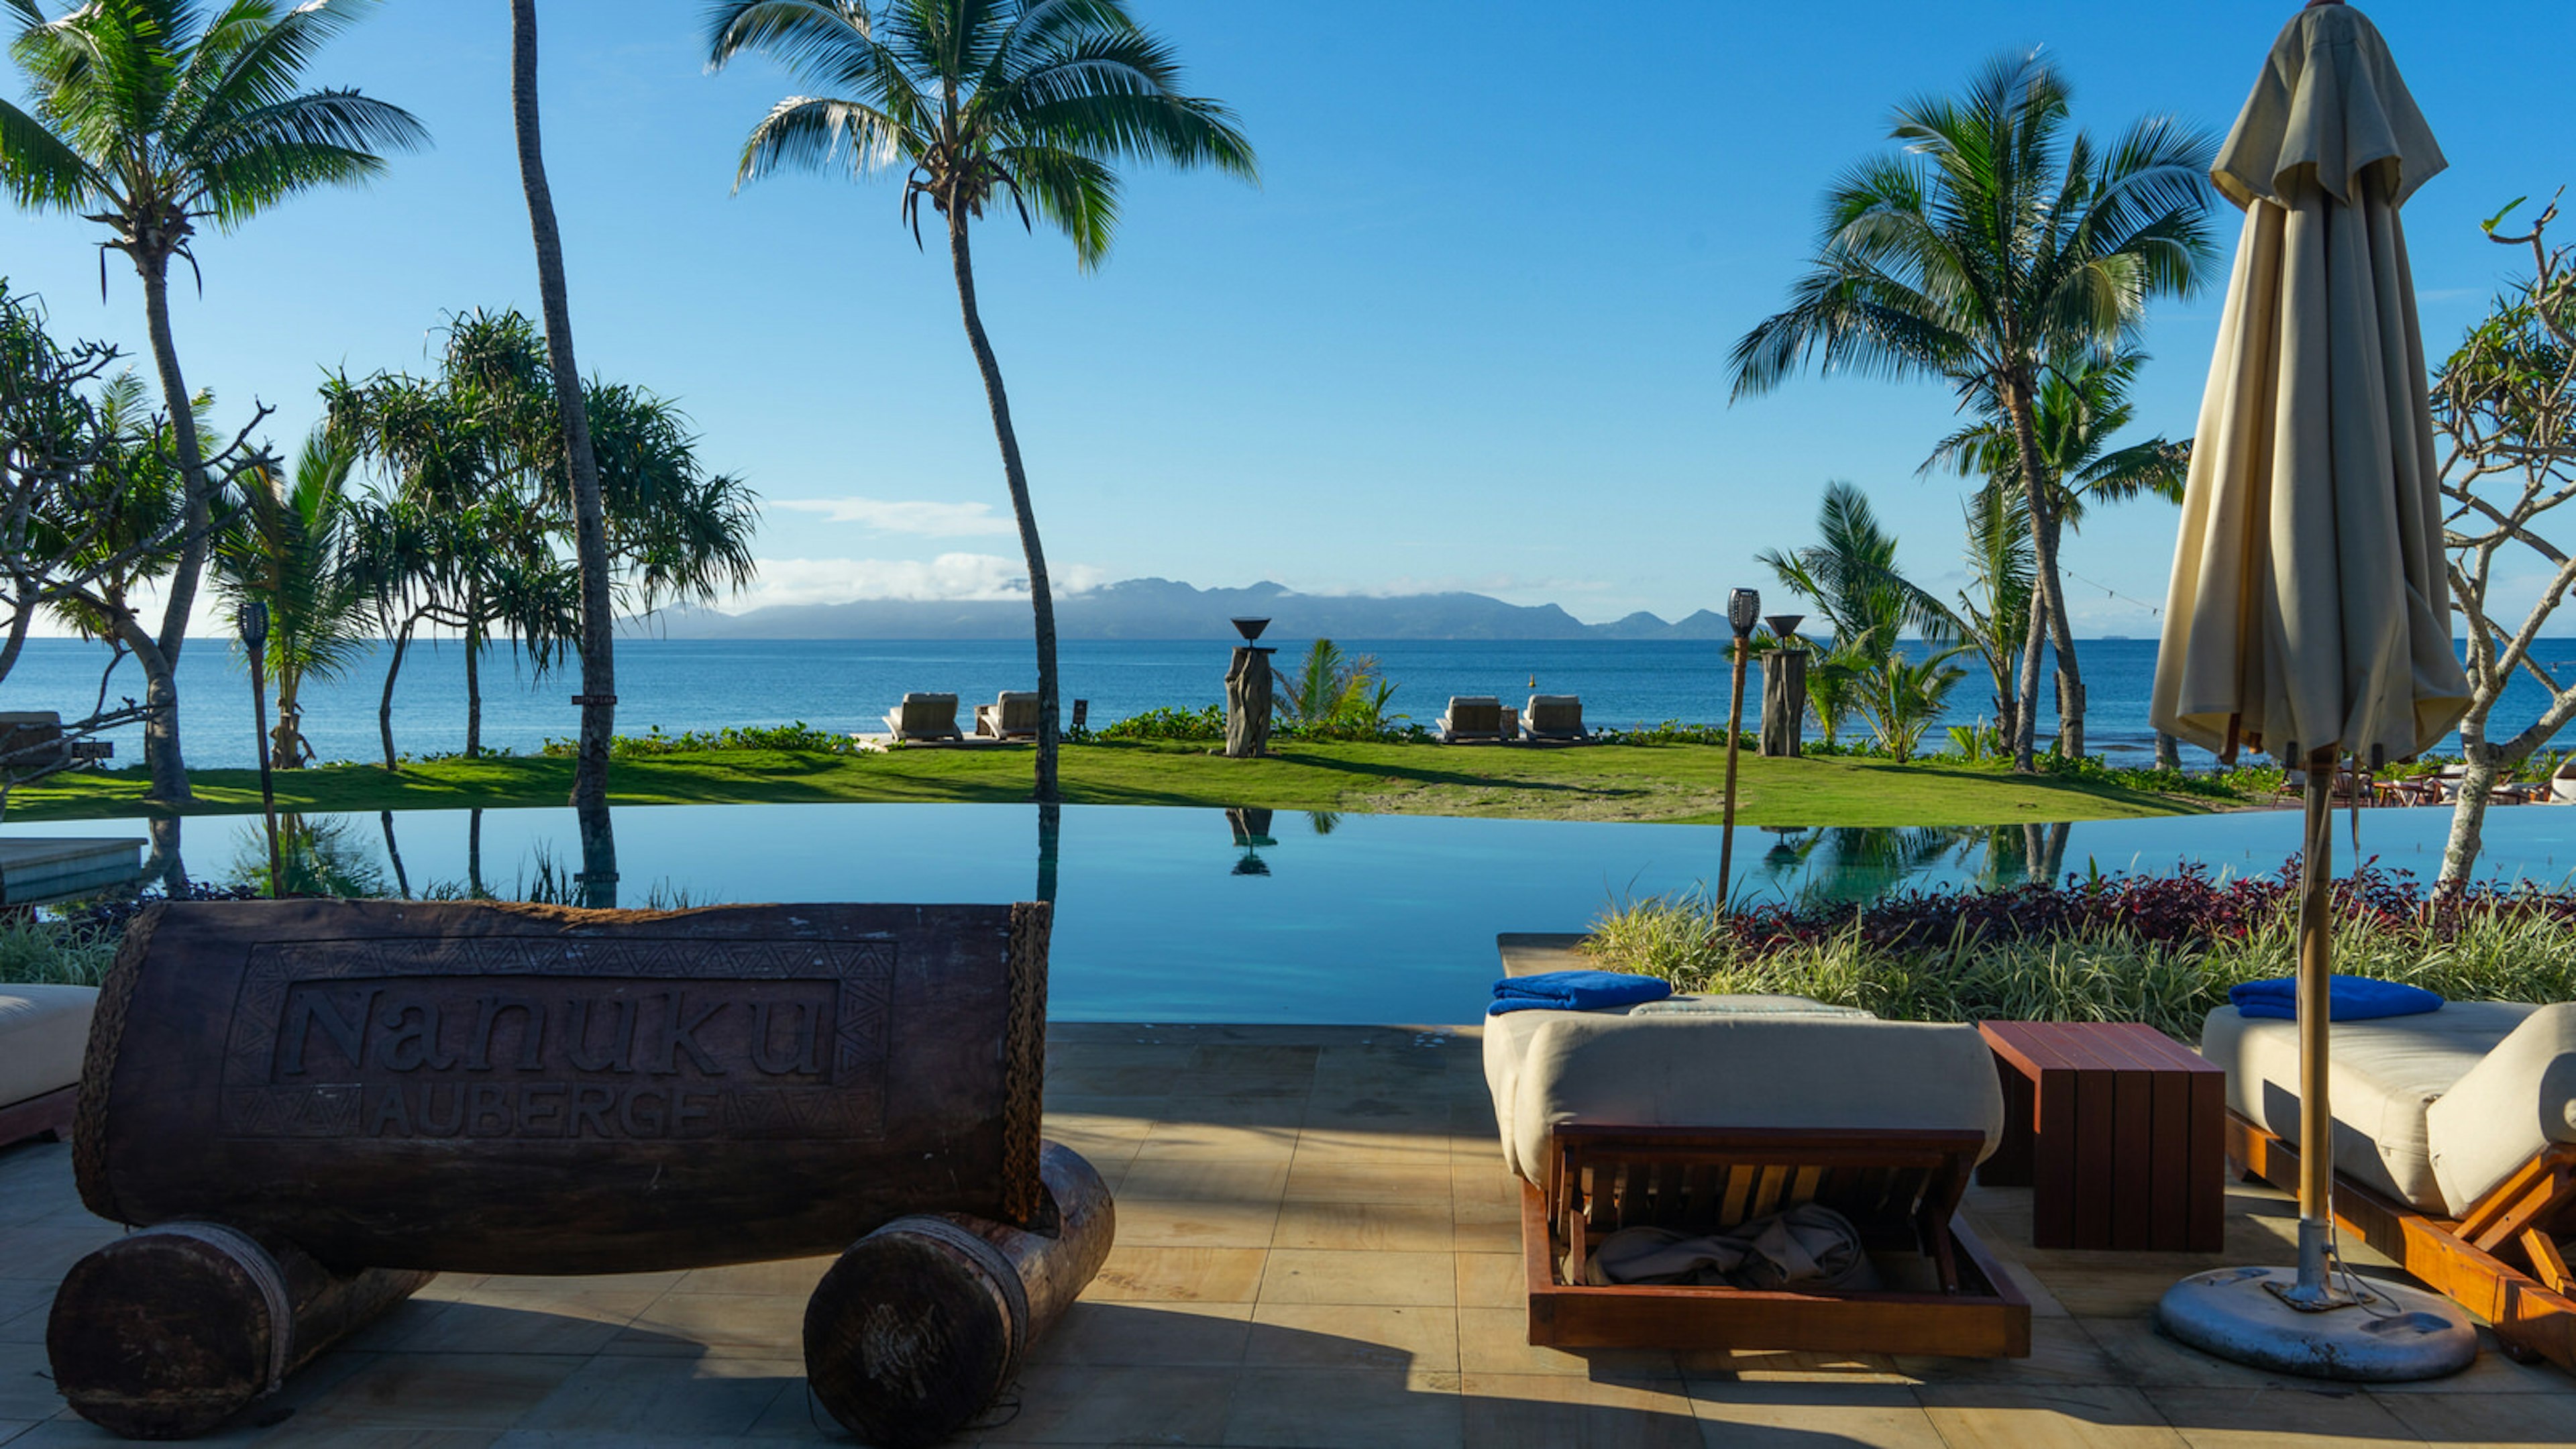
top-left (2151, 0), bottom-right (2475, 1379)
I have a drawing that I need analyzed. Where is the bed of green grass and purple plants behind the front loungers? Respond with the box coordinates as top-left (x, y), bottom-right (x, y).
top-left (1589, 861), bottom-right (2576, 1042)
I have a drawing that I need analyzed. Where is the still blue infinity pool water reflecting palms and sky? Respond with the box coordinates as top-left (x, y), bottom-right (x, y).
top-left (30, 804), bottom-right (2576, 1024)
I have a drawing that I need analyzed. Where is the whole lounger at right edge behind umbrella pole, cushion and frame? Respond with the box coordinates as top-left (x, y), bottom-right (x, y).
top-left (2200, 1000), bottom-right (2576, 1372)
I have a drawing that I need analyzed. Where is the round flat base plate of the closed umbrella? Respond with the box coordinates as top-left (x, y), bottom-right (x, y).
top-left (2156, 1269), bottom-right (2478, 1385)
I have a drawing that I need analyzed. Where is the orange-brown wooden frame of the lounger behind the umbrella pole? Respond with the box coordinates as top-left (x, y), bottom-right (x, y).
top-left (2229, 1112), bottom-right (2576, 1372)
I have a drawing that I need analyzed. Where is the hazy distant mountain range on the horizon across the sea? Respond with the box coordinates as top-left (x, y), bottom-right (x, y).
top-left (654, 578), bottom-right (1726, 639)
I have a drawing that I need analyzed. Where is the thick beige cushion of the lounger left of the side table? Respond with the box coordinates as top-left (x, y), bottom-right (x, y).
top-left (1484, 1011), bottom-right (2004, 1181)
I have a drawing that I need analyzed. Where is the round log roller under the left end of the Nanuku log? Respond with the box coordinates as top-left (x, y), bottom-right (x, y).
top-left (44, 1222), bottom-right (435, 1439)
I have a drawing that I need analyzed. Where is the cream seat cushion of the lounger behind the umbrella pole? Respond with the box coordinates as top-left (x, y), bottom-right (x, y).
top-left (2200, 1000), bottom-right (2537, 1214)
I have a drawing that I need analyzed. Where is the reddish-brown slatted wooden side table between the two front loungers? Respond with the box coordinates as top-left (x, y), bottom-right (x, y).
top-left (1976, 1021), bottom-right (2226, 1253)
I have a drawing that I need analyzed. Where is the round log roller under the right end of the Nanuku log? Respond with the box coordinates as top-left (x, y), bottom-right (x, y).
top-left (804, 1142), bottom-right (1118, 1449)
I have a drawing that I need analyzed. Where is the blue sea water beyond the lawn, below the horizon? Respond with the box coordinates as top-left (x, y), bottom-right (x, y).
top-left (0, 629), bottom-right (2576, 765)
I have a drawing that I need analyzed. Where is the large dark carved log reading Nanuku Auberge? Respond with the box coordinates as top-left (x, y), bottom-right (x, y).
top-left (72, 900), bottom-right (1049, 1274)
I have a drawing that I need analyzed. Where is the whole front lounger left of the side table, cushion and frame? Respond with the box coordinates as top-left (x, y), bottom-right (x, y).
top-left (1484, 998), bottom-right (2030, 1358)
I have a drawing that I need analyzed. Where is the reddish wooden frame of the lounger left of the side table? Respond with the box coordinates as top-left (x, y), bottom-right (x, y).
top-left (1520, 1122), bottom-right (2030, 1358)
